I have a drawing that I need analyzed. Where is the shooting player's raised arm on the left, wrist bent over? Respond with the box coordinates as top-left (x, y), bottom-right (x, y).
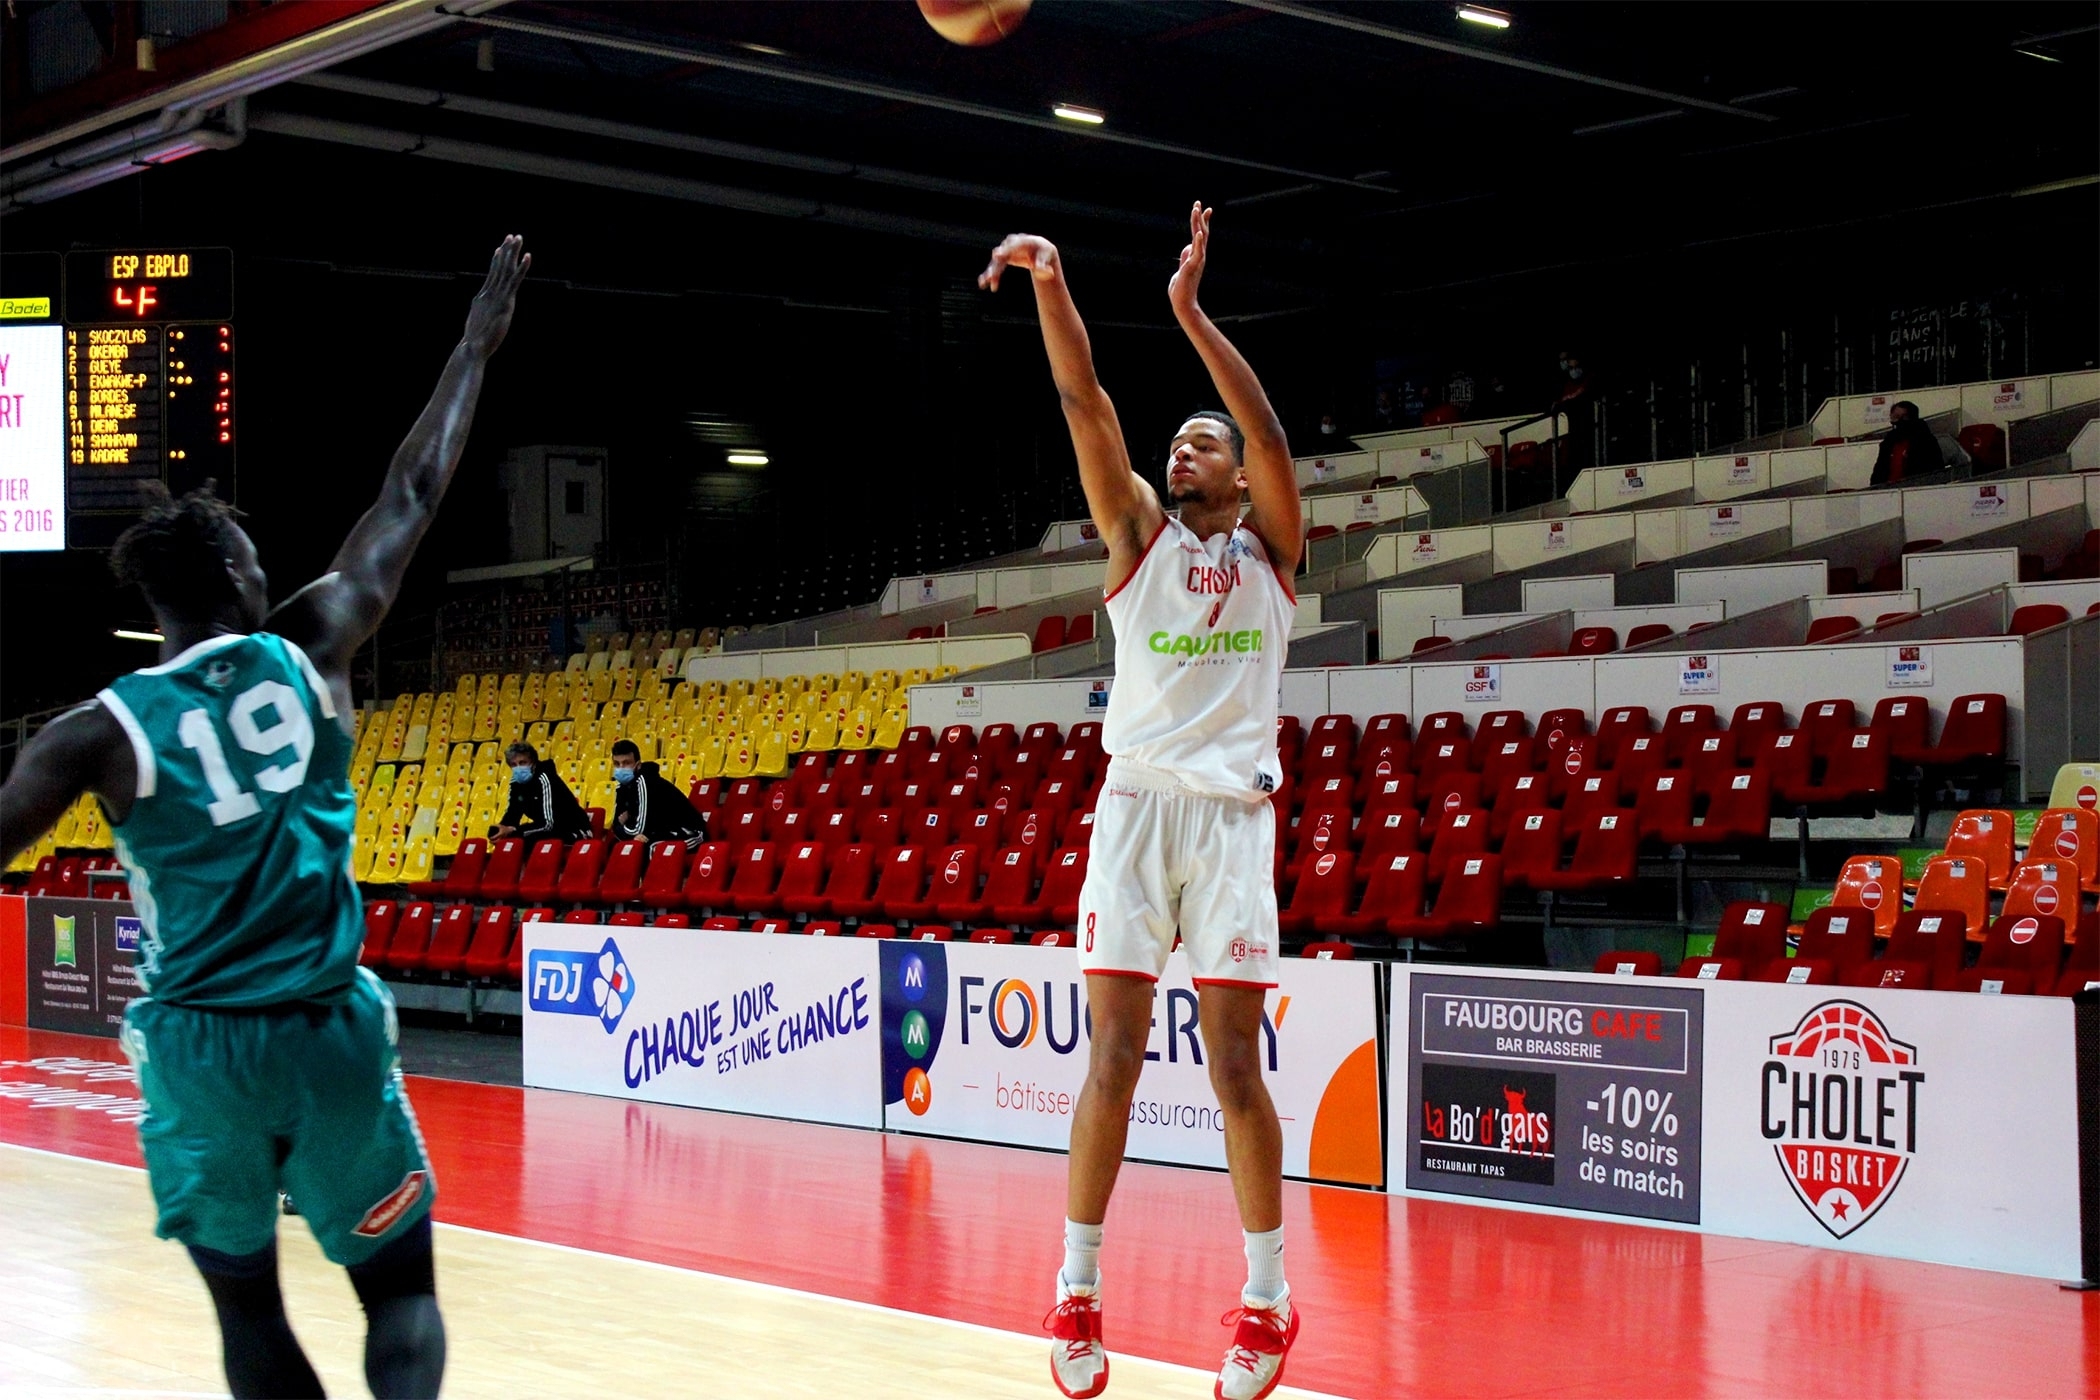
top-left (977, 233), bottom-right (1166, 590)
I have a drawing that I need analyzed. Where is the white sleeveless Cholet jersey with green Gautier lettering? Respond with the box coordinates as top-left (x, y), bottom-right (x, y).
top-left (1100, 516), bottom-right (1298, 802)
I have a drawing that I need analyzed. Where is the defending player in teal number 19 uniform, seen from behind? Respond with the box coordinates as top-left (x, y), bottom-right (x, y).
top-left (0, 237), bottom-right (531, 1396)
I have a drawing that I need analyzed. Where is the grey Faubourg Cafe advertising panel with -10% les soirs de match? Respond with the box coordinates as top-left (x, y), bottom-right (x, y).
top-left (1392, 972), bottom-right (1701, 1224)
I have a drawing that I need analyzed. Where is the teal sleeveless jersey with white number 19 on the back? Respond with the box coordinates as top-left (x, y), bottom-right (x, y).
top-left (99, 632), bottom-right (363, 1007)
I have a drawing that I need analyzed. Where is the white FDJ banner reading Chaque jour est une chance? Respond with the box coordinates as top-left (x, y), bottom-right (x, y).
top-left (533, 924), bottom-right (882, 1127)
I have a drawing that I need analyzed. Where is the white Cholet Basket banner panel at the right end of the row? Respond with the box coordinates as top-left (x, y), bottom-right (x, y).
top-left (1705, 982), bottom-right (2079, 1278)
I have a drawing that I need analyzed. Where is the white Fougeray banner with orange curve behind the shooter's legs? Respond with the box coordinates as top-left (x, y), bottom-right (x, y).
top-left (880, 942), bottom-right (1384, 1186)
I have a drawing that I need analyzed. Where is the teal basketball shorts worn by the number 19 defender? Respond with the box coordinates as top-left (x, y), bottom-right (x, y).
top-left (124, 968), bottom-right (437, 1268)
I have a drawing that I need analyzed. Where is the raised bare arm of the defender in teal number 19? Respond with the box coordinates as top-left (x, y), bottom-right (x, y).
top-left (269, 235), bottom-right (531, 676)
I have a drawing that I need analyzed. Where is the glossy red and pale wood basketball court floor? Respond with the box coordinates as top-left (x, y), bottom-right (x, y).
top-left (0, 1028), bottom-right (2100, 1400)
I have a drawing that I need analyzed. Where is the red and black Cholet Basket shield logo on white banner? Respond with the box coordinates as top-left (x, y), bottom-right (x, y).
top-left (1758, 1001), bottom-right (1926, 1238)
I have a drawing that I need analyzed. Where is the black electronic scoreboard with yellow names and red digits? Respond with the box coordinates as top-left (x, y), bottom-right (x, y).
top-left (65, 248), bottom-right (233, 546)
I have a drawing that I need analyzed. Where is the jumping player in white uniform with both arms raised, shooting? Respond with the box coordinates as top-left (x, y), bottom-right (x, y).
top-left (979, 204), bottom-right (1304, 1400)
